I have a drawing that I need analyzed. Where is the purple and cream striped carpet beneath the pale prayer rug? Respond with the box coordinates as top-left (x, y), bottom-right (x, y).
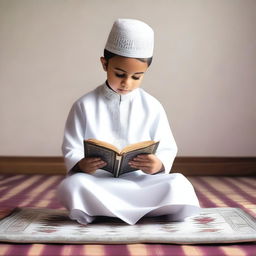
top-left (0, 175), bottom-right (256, 256)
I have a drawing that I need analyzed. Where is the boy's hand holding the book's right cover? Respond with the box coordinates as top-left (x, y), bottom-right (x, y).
top-left (129, 154), bottom-right (163, 174)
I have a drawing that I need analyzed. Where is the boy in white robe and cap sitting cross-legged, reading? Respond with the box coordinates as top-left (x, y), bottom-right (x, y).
top-left (58, 19), bottom-right (199, 224)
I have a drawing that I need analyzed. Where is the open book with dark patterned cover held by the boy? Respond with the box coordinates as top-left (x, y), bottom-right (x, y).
top-left (84, 139), bottom-right (159, 177)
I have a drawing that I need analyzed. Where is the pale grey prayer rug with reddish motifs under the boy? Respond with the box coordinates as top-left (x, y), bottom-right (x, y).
top-left (0, 208), bottom-right (256, 244)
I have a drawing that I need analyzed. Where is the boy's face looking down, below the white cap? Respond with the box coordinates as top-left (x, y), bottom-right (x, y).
top-left (101, 56), bottom-right (148, 94)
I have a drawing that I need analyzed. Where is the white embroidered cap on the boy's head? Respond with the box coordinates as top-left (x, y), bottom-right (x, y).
top-left (105, 19), bottom-right (154, 58)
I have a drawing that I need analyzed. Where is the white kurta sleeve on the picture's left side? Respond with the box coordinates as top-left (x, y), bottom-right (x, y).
top-left (62, 102), bottom-right (85, 171)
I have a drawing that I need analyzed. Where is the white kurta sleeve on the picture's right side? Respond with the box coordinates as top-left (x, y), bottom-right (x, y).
top-left (152, 105), bottom-right (177, 173)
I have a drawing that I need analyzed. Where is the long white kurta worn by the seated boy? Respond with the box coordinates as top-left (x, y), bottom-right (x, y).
top-left (58, 84), bottom-right (199, 224)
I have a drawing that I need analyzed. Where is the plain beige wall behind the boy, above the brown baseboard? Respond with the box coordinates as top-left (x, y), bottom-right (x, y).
top-left (0, 0), bottom-right (256, 156)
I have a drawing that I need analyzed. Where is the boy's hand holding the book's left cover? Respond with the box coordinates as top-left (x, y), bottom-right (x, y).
top-left (78, 157), bottom-right (107, 173)
